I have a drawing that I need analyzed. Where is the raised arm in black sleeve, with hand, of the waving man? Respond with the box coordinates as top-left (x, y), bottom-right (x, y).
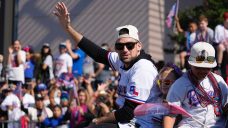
top-left (54, 2), bottom-right (109, 65)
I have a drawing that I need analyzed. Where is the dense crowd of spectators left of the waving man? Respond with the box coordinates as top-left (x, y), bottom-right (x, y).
top-left (0, 40), bottom-right (118, 128)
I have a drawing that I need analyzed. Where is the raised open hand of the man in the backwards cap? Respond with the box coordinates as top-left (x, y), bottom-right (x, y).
top-left (53, 2), bottom-right (70, 29)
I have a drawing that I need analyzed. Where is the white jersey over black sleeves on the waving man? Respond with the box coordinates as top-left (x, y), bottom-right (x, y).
top-left (108, 52), bottom-right (158, 124)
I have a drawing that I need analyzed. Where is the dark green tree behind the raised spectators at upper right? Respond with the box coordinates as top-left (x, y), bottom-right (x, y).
top-left (167, 0), bottom-right (228, 53)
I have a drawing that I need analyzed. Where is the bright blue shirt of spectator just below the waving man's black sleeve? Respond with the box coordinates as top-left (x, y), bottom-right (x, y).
top-left (72, 49), bottom-right (86, 77)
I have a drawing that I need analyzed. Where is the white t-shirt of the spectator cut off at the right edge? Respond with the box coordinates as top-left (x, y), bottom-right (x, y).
top-left (215, 25), bottom-right (228, 44)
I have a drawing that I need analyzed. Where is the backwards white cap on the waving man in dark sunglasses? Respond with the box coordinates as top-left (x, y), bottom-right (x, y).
top-left (116, 25), bottom-right (139, 41)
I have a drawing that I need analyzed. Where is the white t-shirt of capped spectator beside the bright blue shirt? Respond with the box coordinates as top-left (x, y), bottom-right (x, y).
top-left (55, 53), bottom-right (73, 77)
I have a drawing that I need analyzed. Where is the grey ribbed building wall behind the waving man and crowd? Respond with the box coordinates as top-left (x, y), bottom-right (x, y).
top-left (1, 0), bottom-right (202, 61)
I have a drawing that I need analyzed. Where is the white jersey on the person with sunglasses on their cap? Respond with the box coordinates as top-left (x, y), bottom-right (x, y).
top-left (167, 73), bottom-right (228, 128)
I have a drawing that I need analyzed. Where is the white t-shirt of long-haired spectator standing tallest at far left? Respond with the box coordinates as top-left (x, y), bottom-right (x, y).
top-left (8, 50), bottom-right (26, 83)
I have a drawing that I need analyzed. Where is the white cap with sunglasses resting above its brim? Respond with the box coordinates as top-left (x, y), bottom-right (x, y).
top-left (188, 42), bottom-right (217, 68)
